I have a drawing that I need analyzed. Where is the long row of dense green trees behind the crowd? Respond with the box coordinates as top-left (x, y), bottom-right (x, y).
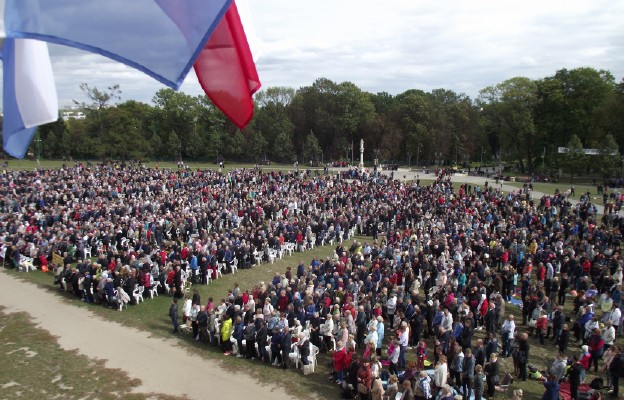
top-left (26, 67), bottom-right (624, 176)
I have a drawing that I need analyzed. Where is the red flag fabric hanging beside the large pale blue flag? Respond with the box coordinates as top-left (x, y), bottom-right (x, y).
top-left (193, 2), bottom-right (260, 129)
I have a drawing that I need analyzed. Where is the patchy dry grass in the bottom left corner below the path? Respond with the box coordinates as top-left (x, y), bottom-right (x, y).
top-left (0, 309), bottom-right (182, 400)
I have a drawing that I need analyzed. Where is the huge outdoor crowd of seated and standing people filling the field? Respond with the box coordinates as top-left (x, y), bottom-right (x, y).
top-left (0, 164), bottom-right (624, 400)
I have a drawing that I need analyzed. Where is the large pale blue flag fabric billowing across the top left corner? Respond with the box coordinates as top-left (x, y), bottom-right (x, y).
top-left (4, 0), bottom-right (232, 89)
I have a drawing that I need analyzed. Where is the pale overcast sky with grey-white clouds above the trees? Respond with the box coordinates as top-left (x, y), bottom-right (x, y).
top-left (17, 0), bottom-right (624, 107)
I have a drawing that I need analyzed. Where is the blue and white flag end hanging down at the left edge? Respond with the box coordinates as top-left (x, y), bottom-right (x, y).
top-left (1, 38), bottom-right (58, 158)
